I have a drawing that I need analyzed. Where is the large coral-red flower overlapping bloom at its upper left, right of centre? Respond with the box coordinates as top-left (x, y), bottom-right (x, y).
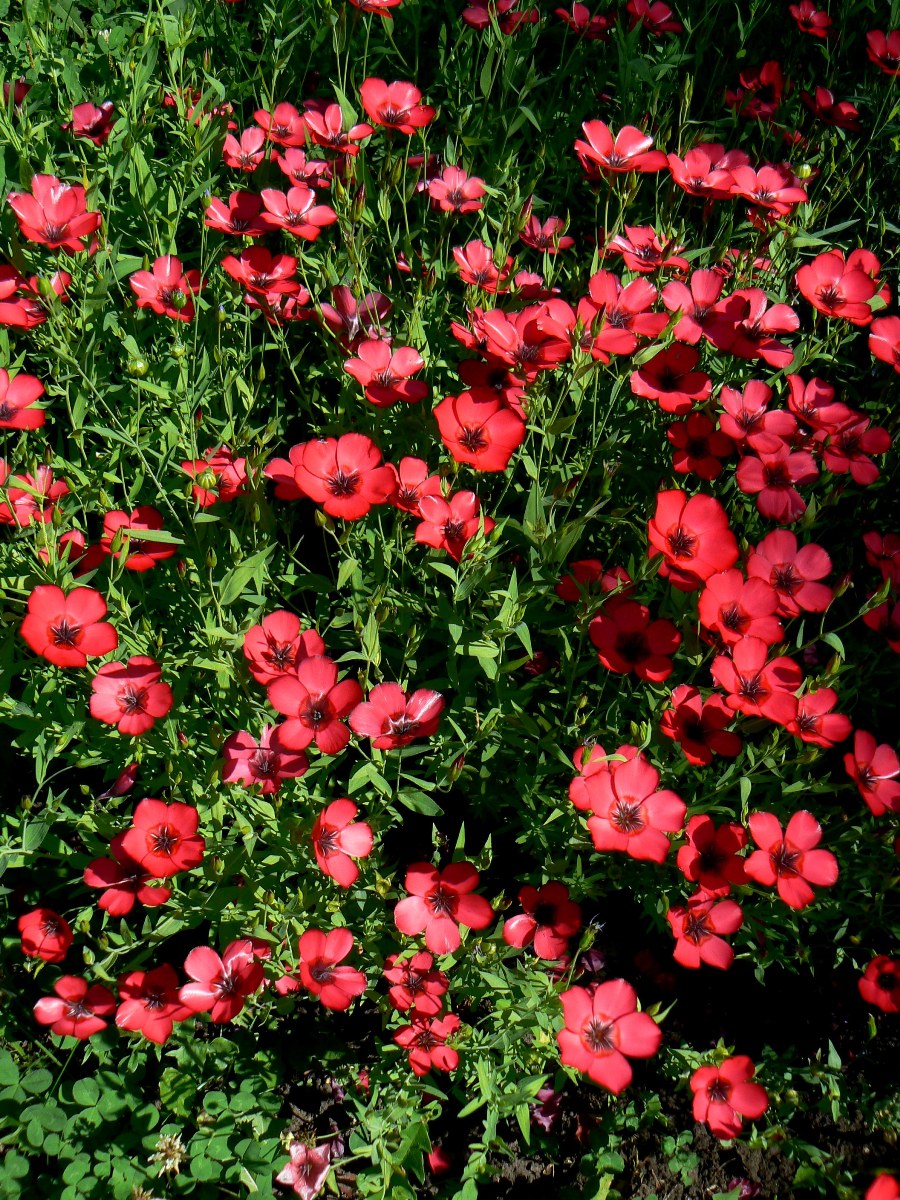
top-left (588, 754), bottom-right (688, 863)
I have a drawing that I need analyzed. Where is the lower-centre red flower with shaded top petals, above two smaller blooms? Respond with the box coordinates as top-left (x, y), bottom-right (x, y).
top-left (394, 863), bottom-right (493, 954)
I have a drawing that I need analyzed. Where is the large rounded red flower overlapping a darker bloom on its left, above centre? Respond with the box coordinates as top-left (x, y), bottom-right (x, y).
top-left (294, 433), bottom-right (394, 521)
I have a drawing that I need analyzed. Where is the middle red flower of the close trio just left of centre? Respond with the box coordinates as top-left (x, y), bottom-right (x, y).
top-left (269, 655), bottom-right (362, 755)
